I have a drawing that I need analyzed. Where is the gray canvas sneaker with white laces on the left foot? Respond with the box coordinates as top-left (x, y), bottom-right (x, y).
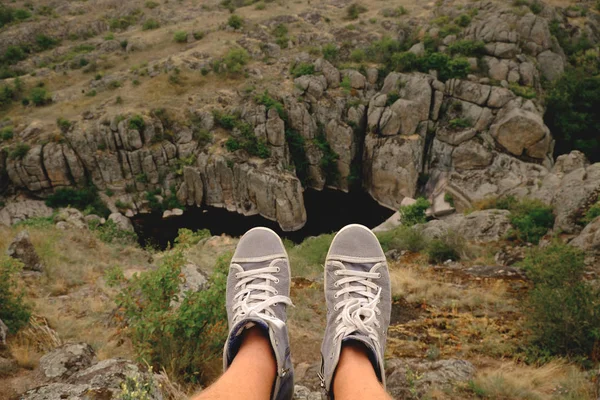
top-left (223, 228), bottom-right (294, 400)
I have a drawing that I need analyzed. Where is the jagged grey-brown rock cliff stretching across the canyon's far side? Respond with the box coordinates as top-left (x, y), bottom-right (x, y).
top-left (0, 1), bottom-right (600, 232)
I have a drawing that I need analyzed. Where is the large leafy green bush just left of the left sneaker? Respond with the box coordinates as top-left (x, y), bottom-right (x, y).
top-left (116, 251), bottom-right (230, 383)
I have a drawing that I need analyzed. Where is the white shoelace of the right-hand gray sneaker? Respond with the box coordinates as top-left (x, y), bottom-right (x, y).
top-left (331, 261), bottom-right (382, 347)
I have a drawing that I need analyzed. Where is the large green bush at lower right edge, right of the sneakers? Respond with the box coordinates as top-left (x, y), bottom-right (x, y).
top-left (520, 242), bottom-right (600, 359)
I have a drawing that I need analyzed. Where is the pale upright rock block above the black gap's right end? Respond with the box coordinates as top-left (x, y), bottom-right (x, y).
top-left (364, 134), bottom-right (423, 209)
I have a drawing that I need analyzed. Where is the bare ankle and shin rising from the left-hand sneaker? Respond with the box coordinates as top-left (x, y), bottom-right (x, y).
top-left (192, 328), bottom-right (277, 400)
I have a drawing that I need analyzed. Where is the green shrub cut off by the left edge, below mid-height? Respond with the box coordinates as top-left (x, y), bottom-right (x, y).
top-left (0, 257), bottom-right (31, 334)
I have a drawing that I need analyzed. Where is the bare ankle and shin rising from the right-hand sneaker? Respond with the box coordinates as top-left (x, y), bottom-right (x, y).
top-left (333, 343), bottom-right (392, 400)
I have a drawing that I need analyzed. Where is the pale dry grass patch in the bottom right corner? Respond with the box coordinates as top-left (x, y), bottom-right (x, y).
top-left (471, 361), bottom-right (596, 400)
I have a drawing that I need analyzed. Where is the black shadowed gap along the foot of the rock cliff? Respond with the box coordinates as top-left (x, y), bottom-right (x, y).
top-left (132, 189), bottom-right (394, 249)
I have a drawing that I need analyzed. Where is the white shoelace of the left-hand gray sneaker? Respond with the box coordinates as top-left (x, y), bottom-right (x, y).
top-left (231, 259), bottom-right (293, 329)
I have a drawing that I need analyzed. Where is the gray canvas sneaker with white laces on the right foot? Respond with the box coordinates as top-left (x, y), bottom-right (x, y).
top-left (319, 225), bottom-right (392, 398)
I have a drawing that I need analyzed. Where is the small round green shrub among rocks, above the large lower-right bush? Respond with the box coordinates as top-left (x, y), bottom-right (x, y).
top-left (509, 199), bottom-right (554, 244)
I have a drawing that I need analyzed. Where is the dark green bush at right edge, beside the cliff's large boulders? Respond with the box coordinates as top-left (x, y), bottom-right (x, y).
top-left (544, 70), bottom-right (600, 162)
